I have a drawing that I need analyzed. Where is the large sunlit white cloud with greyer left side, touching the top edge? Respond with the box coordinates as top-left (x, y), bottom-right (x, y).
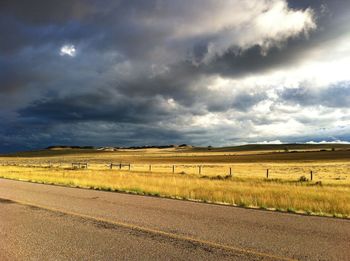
top-left (136, 0), bottom-right (316, 62)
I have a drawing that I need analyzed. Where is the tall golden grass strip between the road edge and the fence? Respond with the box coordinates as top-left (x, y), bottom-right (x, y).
top-left (0, 166), bottom-right (350, 218)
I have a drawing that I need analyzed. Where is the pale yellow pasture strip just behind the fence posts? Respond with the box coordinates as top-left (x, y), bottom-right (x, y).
top-left (0, 158), bottom-right (350, 185)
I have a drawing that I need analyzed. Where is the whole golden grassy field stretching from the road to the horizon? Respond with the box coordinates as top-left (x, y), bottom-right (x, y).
top-left (0, 146), bottom-right (350, 218)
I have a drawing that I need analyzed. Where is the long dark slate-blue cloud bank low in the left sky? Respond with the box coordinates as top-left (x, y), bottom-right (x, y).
top-left (19, 92), bottom-right (186, 124)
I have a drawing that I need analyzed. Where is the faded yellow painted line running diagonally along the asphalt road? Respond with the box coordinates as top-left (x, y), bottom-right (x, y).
top-left (2, 198), bottom-right (297, 261)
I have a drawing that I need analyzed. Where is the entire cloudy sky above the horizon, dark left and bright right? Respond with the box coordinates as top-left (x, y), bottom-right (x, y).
top-left (0, 0), bottom-right (350, 152)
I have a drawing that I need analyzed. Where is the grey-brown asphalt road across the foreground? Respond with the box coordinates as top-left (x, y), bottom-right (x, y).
top-left (0, 179), bottom-right (350, 260)
